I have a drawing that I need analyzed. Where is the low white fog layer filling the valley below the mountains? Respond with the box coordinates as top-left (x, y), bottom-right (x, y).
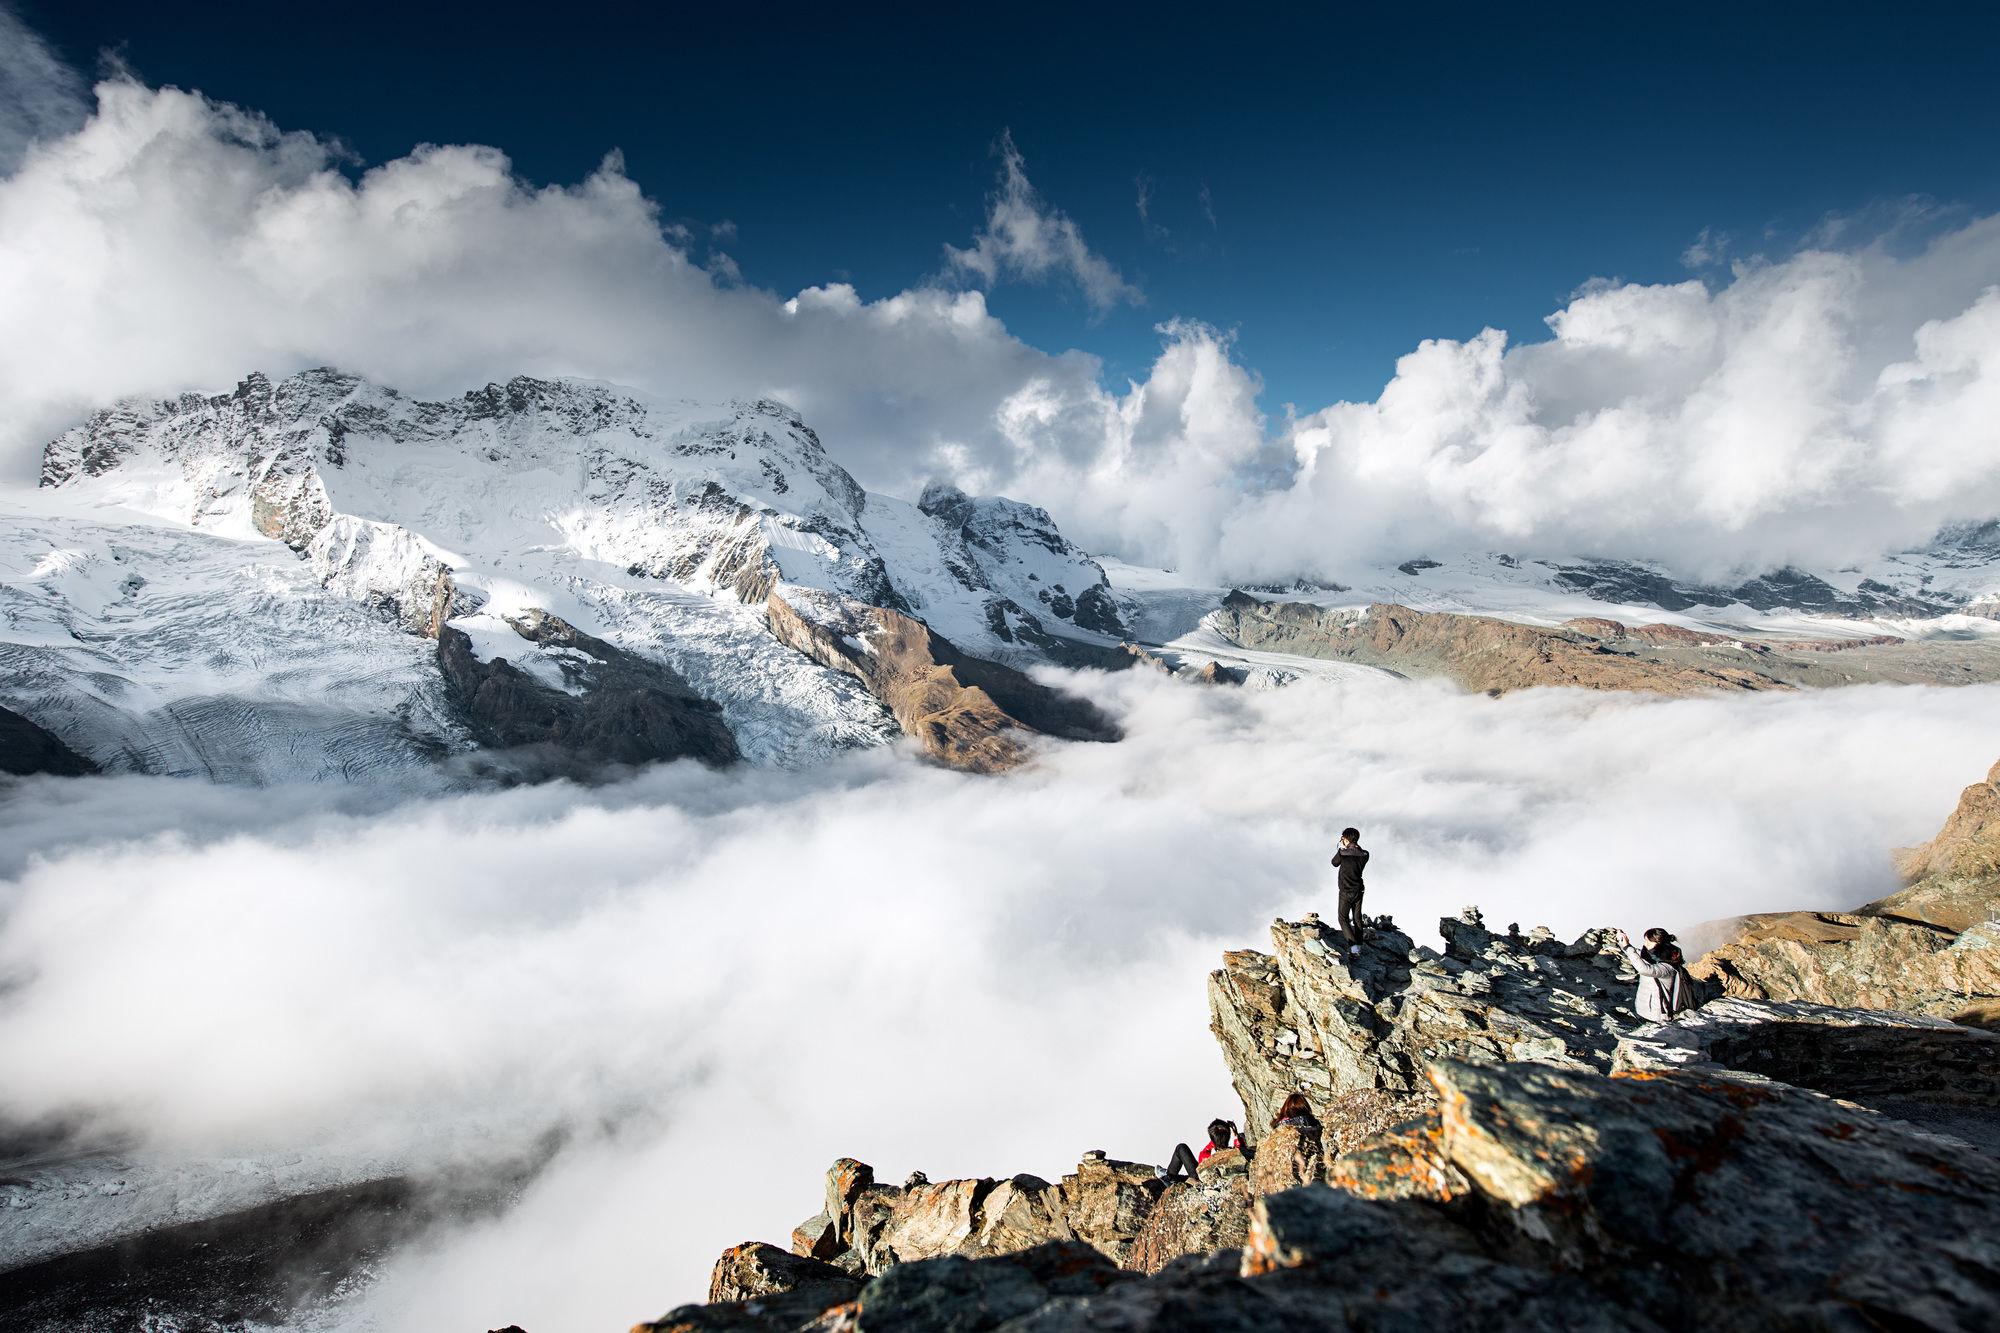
top-left (0, 673), bottom-right (2000, 1333)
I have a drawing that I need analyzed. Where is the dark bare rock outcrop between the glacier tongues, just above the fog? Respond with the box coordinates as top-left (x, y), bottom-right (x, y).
top-left (438, 610), bottom-right (738, 777)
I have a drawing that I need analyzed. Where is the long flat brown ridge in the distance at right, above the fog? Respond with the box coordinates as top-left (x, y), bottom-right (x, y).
top-left (1208, 592), bottom-right (2000, 695)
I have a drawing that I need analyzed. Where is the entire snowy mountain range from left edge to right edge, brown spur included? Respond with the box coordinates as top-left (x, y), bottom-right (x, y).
top-left (11, 370), bottom-right (2000, 783)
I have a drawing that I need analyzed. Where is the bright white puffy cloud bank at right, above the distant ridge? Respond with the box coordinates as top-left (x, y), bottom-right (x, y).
top-left (1002, 216), bottom-right (2000, 580)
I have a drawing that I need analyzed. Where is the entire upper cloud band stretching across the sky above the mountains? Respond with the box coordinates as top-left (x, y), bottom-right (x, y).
top-left (0, 23), bottom-right (2000, 580)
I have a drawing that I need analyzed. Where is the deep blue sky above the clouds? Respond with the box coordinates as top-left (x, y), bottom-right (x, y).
top-left (31, 2), bottom-right (2000, 412)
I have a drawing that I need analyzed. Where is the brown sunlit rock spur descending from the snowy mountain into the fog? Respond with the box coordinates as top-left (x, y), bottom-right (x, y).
top-left (766, 588), bottom-right (1120, 773)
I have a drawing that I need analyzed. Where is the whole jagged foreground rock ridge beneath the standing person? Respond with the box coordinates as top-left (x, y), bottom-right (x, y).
top-left (638, 892), bottom-right (2000, 1333)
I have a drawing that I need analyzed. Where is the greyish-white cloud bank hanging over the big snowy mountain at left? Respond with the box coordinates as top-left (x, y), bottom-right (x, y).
top-left (0, 78), bottom-right (1098, 492)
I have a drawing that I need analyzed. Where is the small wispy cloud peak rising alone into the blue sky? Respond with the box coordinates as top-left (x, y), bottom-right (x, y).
top-left (944, 132), bottom-right (1148, 314)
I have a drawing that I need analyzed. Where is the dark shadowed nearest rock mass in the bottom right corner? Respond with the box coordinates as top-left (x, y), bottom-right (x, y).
top-left (656, 1007), bottom-right (2000, 1333)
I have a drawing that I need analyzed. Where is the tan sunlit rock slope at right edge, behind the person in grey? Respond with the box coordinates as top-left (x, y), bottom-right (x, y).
top-left (1690, 752), bottom-right (2000, 1023)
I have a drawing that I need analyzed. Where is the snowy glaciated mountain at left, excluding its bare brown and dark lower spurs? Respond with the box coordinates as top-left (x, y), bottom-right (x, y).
top-left (0, 370), bottom-right (1122, 781)
